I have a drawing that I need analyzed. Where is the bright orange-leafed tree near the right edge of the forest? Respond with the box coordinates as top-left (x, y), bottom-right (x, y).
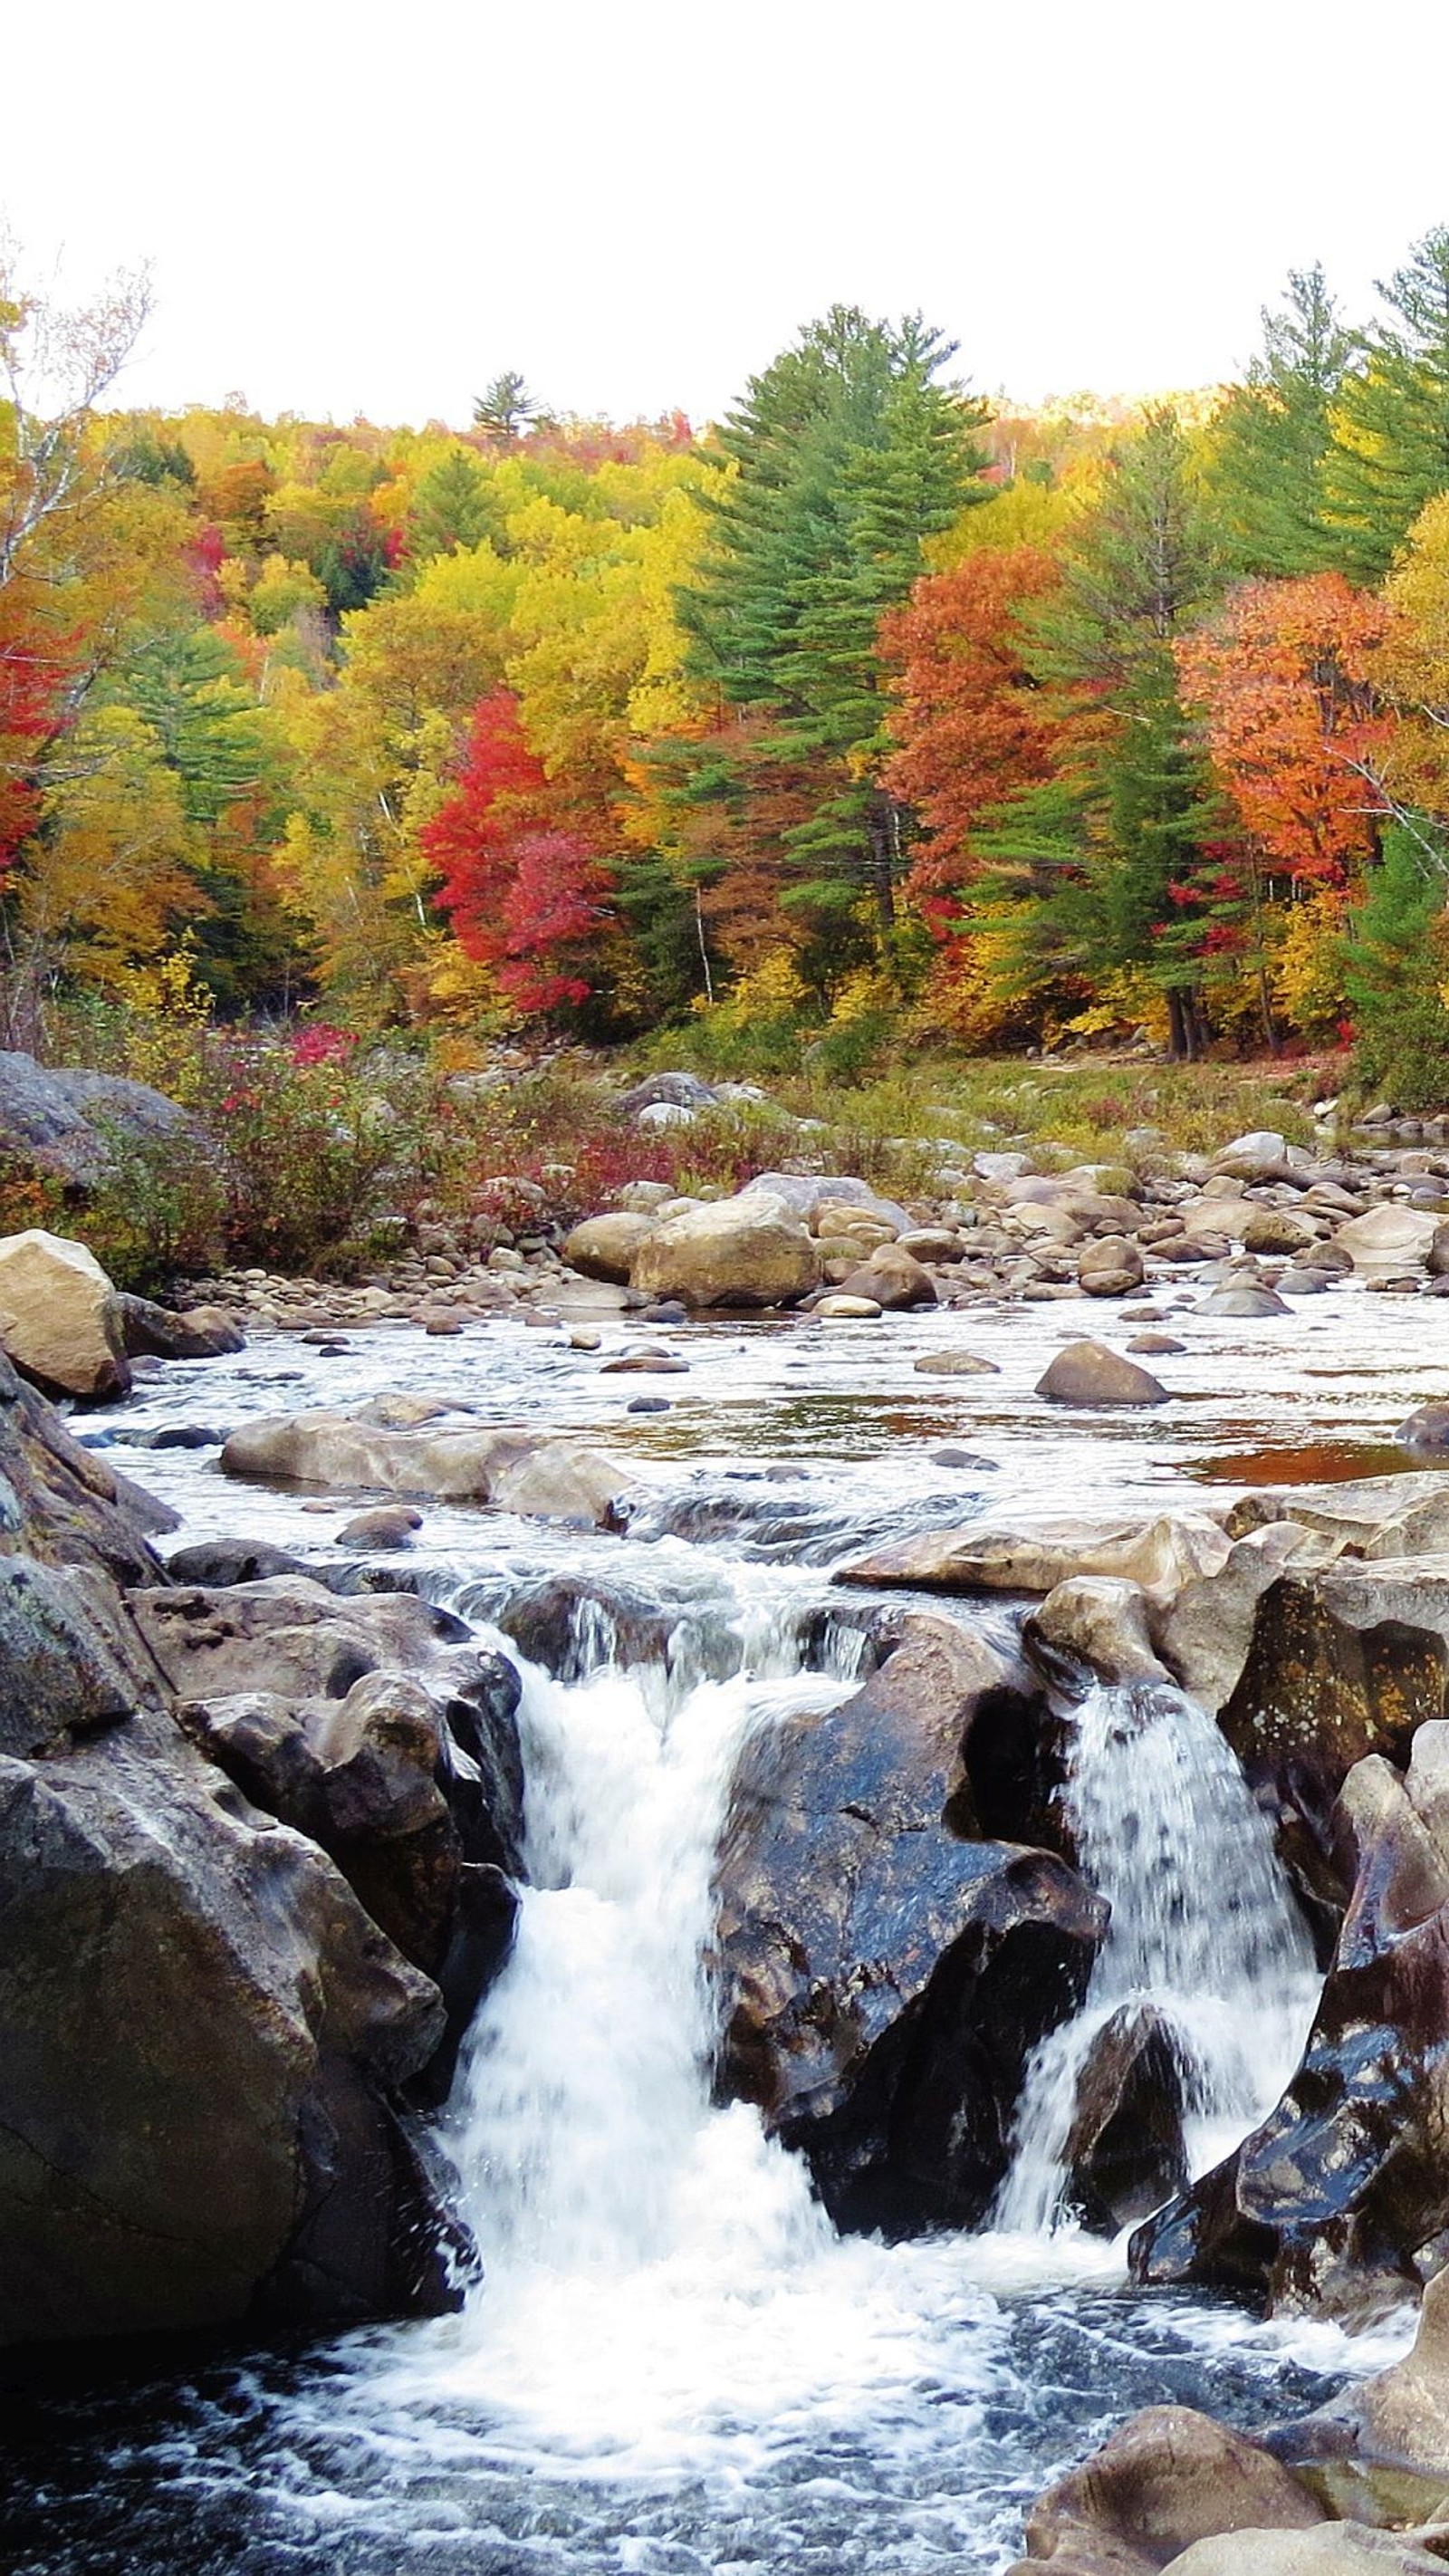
top-left (1176, 572), bottom-right (1395, 889)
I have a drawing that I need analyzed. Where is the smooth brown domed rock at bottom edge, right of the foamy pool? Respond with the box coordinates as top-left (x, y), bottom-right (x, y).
top-left (1022, 2406), bottom-right (1328, 2576)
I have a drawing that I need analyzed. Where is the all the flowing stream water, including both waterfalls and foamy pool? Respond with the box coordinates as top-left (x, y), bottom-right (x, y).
top-left (0, 1296), bottom-right (1439, 2576)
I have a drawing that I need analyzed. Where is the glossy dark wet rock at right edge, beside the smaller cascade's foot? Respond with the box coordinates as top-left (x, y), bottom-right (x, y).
top-left (1132, 1725), bottom-right (1449, 2321)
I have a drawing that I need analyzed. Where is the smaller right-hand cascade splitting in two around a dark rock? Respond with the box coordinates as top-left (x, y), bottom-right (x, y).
top-left (993, 1685), bottom-right (1320, 2236)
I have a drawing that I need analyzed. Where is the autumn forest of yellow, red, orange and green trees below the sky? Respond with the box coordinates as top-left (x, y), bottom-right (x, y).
top-left (0, 229), bottom-right (1449, 1108)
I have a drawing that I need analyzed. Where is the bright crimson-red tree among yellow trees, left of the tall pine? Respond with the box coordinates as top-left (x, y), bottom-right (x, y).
top-left (419, 687), bottom-right (610, 1017)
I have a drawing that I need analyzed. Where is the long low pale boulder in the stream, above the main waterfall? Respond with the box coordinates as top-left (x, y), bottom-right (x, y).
top-left (221, 1407), bottom-right (633, 1525)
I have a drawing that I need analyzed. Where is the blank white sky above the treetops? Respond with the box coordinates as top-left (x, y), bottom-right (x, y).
top-left (11, 0), bottom-right (1449, 422)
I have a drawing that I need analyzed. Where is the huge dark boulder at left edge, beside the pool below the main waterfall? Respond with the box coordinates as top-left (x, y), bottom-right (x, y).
top-left (0, 1710), bottom-right (456, 2341)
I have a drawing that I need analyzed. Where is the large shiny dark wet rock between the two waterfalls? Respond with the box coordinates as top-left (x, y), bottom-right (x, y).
top-left (718, 1618), bottom-right (1104, 2234)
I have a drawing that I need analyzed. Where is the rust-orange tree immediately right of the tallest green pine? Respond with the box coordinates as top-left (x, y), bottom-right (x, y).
top-left (880, 546), bottom-right (1060, 935)
